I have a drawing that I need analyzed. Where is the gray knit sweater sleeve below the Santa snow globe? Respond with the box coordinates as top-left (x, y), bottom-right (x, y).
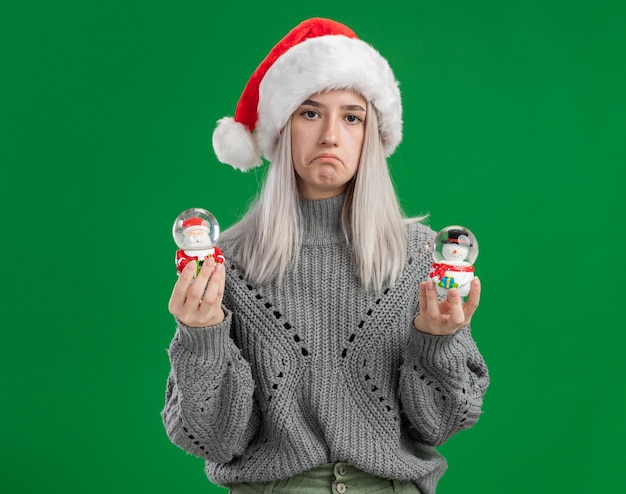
top-left (162, 311), bottom-right (259, 463)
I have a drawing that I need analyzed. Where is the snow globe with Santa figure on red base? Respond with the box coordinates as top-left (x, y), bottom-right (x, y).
top-left (172, 208), bottom-right (224, 275)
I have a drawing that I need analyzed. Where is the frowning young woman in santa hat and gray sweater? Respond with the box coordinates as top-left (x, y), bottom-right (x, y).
top-left (163, 19), bottom-right (489, 494)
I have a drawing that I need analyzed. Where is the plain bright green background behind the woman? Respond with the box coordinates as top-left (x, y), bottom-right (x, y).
top-left (0, 0), bottom-right (626, 494)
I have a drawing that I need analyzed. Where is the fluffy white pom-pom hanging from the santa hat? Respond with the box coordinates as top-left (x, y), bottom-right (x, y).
top-left (213, 117), bottom-right (263, 172)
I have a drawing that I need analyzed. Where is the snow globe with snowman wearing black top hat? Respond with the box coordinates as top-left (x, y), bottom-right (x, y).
top-left (430, 225), bottom-right (478, 297)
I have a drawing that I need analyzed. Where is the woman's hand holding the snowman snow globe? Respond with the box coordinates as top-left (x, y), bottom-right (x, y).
top-left (413, 278), bottom-right (480, 335)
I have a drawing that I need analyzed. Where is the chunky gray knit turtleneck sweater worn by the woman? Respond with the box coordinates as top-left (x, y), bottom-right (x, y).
top-left (162, 196), bottom-right (489, 494)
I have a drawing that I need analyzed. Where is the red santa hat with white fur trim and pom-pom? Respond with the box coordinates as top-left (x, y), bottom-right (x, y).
top-left (213, 18), bottom-right (402, 171)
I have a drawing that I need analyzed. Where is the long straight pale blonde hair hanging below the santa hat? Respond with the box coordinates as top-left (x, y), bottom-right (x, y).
top-left (222, 102), bottom-right (422, 290)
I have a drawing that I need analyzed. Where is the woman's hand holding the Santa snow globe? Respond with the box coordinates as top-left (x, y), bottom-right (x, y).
top-left (168, 260), bottom-right (226, 328)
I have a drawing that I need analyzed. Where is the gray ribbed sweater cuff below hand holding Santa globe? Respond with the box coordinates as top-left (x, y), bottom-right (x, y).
top-left (176, 309), bottom-right (234, 359)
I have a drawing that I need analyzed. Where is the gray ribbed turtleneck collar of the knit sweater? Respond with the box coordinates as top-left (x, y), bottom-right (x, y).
top-left (300, 194), bottom-right (346, 245)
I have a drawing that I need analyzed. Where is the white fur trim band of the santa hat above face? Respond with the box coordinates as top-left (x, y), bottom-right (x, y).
top-left (256, 35), bottom-right (402, 161)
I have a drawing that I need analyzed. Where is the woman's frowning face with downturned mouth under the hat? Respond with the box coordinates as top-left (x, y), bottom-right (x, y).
top-left (291, 89), bottom-right (367, 199)
